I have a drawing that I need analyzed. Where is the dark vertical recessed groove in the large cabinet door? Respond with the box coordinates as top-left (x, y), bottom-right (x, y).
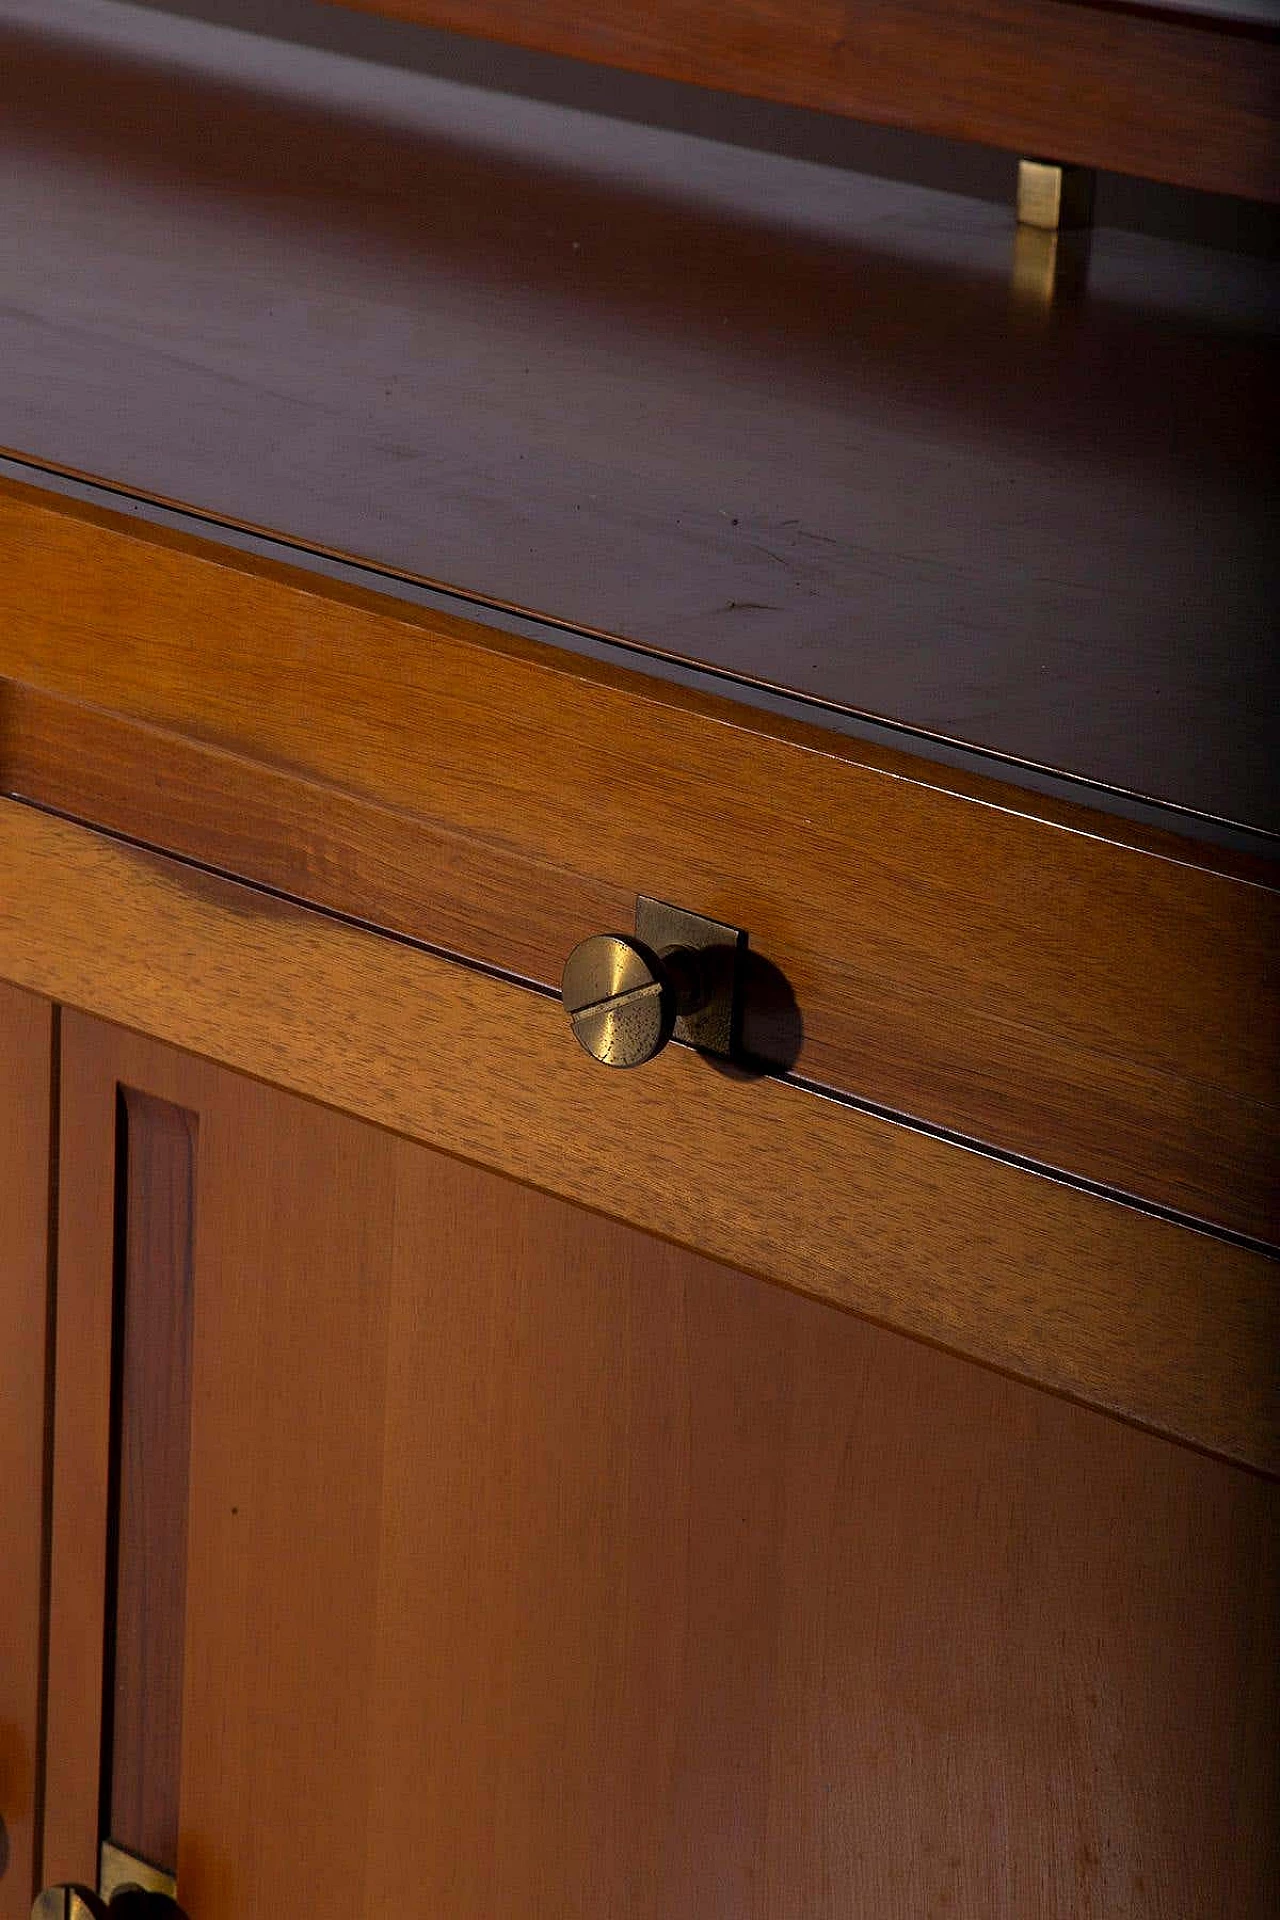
top-left (107, 1087), bottom-right (196, 1870)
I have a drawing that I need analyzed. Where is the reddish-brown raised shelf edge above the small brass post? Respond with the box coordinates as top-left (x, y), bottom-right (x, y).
top-left (330, 0), bottom-right (1280, 200)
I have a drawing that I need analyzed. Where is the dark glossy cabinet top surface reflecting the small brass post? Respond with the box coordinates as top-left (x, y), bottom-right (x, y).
top-left (0, 0), bottom-right (1280, 828)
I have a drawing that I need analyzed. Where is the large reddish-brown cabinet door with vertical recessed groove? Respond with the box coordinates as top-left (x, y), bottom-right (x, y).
top-left (44, 1014), bottom-right (1276, 1920)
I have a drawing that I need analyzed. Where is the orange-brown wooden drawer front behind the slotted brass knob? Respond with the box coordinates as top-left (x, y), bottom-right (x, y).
top-left (0, 470), bottom-right (1280, 1238)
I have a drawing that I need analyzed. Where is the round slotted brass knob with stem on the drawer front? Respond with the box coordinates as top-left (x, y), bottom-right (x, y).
top-left (560, 933), bottom-right (702, 1068)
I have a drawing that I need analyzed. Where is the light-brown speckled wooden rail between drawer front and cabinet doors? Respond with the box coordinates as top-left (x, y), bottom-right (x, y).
top-left (0, 804), bottom-right (1280, 1469)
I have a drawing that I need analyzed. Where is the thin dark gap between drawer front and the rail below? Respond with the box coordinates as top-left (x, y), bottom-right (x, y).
top-left (0, 789), bottom-right (1280, 1260)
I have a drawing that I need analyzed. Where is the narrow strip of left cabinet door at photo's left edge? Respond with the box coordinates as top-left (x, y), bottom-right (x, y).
top-left (0, 981), bottom-right (54, 1920)
